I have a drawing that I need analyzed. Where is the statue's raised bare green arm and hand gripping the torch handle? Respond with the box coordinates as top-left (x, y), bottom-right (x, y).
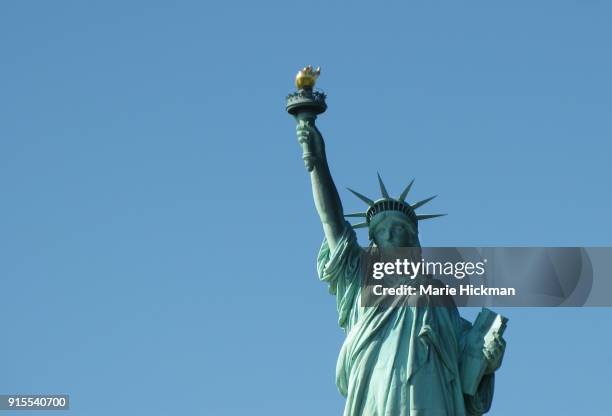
top-left (296, 120), bottom-right (344, 252)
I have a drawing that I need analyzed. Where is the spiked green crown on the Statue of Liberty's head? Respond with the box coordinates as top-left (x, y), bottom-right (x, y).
top-left (344, 174), bottom-right (446, 232)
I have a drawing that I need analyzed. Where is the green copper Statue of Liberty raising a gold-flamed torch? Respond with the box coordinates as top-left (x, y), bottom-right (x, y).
top-left (287, 67), bottom-right (505, 416)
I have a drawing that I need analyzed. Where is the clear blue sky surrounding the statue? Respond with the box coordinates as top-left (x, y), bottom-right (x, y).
top-left (0, 0), bottom-right (612, 416)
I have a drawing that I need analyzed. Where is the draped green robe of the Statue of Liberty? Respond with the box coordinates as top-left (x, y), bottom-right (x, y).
top-left (317, 223), bottom-right (494, 416)
